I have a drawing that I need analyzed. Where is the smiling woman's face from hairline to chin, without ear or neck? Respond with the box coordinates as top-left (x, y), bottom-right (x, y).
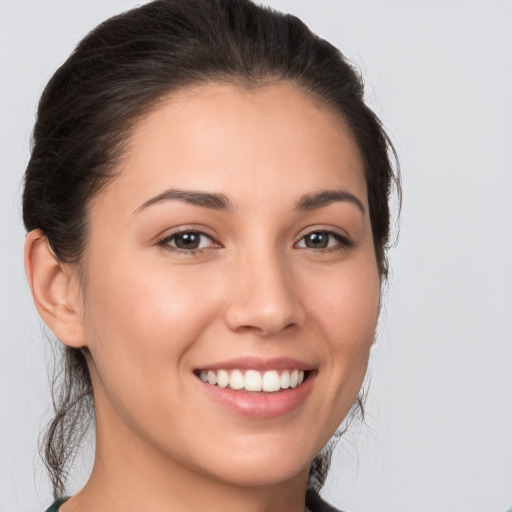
top-left (76, 84), bottom-right (380, 485)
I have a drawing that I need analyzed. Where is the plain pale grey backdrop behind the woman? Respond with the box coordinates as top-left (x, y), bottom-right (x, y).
top-left (0, 0), bottom-right (512, 512)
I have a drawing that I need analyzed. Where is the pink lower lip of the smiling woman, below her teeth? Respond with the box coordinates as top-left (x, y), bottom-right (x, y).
top-left (197, 372), bottom-right (315, 419)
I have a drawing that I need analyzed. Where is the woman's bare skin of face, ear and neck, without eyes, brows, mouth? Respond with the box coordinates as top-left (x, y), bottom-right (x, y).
top-left (26, 83), bottom-right (380, 512)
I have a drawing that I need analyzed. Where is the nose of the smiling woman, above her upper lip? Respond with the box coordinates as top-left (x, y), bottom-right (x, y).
top-left (225, 253), bottom-right (305, 336)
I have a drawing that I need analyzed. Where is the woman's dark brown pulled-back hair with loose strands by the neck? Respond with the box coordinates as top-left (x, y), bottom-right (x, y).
top-left (23, 0), bottom-right (399, 497)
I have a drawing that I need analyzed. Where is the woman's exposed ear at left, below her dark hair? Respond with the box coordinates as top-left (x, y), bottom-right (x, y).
top-left (25, 229), bottom-right (86, 348)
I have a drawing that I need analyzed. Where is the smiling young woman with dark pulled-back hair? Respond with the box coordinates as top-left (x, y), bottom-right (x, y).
top-left (23, 0), bottom-right (400, 512)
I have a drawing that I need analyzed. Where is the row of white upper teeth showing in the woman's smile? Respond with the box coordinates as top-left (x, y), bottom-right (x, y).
top-left (199, 370), bottom-right (304, 393)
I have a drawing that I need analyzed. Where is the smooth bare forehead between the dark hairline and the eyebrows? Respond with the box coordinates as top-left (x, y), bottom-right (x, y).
top-left (98, 83), bottom-right (366, 211)
